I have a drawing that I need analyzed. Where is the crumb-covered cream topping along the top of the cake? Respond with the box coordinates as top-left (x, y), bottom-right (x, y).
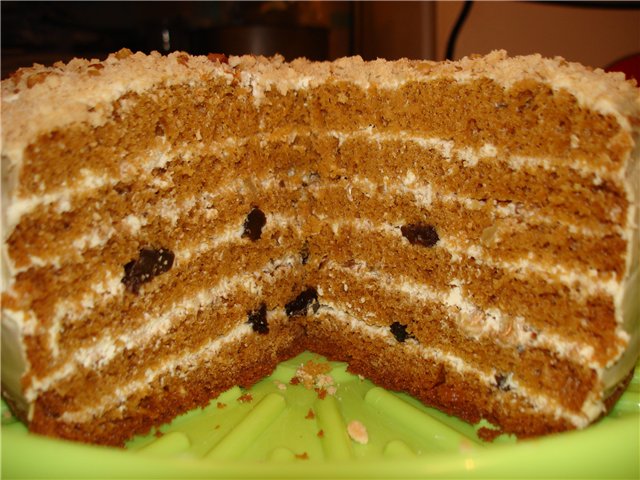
top-left (2, 50), bottom-right (640, 168)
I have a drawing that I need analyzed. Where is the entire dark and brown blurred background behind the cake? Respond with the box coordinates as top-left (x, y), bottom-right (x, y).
top-left (0, 1), bottom-right (640, 78)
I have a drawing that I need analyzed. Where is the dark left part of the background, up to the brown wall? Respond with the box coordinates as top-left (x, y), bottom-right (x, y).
top-left (0, 1), bottom-right (357, 77)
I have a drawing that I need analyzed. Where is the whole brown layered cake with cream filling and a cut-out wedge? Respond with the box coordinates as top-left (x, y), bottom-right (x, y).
top-left (2, 50), bottom-right (640, 445)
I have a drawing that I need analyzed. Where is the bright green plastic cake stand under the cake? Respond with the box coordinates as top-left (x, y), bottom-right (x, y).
top-left (2, 352), bottom-right (640, 479)
